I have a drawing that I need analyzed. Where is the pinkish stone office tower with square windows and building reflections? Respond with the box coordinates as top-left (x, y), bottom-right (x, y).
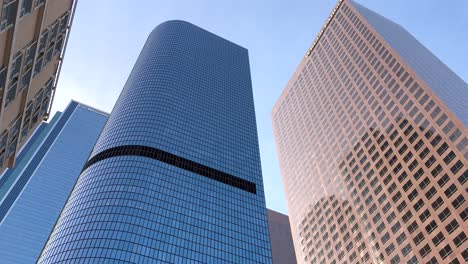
top-left (272, 0), bottom-right (468, 263)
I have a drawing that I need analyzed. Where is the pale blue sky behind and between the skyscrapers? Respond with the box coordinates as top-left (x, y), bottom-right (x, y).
top-left (53, 0), bottom-right (468, 213)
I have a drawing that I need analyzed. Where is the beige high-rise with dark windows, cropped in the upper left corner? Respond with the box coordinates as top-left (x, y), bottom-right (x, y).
top-left (0, 0), bottom-right (77, 174)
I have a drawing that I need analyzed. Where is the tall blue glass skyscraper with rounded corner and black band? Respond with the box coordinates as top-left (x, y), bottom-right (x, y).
top-left (39, 21), bottom-right (271, 263)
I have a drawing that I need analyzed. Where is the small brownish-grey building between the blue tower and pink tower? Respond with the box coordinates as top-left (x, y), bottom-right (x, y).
top-left (267, 209), bottom-right (297, 264)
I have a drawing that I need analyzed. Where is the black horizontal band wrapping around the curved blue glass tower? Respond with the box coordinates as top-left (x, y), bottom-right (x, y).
top-left (82, 145), bottom-right (257, 194)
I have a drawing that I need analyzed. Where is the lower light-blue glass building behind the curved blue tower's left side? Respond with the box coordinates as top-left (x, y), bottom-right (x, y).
top-left (0, 101), bottom-right (107, 264)
